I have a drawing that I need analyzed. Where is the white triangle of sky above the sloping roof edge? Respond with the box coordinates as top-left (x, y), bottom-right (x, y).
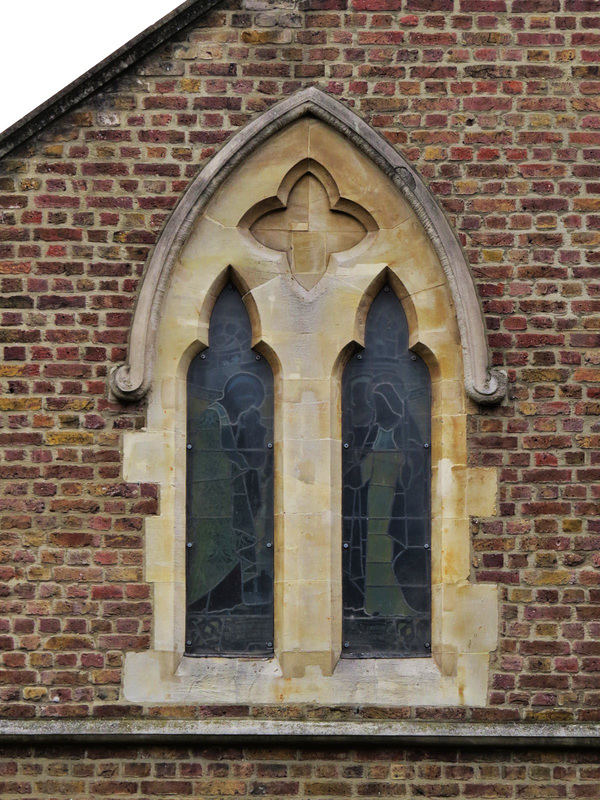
top-left (0, 0), bottom-right (183, 132)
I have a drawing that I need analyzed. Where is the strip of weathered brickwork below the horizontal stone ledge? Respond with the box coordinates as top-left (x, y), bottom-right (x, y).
top-left (0, 746), bottom-right (600, 800)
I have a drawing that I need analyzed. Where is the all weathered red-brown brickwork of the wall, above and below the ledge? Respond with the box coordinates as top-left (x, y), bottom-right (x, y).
top-left (0, 0), bottom-right (600, 732)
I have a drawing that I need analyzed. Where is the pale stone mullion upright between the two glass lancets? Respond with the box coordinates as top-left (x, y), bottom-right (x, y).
top-left (275, 348), bottom-right (340, 677)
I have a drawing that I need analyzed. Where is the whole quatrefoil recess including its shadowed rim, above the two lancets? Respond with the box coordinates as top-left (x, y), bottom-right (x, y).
top-left (240, 159), bottom-right (377, 291)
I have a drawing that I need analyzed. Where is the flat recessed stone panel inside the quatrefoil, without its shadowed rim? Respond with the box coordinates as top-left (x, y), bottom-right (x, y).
top-left (250, 172), bottom-right (367, 291)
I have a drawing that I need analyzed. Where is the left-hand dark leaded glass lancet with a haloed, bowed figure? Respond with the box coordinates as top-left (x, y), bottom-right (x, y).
top-left (186, 286), bottom-right (273, 656)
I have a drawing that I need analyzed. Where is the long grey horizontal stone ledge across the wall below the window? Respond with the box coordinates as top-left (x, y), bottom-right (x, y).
top-left (0, 719), bottom-right (600, 748)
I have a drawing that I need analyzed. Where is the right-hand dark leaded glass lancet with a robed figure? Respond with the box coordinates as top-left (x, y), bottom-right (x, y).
top-left (342, 286), bottom-right (431, 658)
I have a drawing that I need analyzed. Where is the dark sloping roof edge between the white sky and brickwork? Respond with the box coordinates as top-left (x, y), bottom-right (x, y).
top-left (0, 0), bottom-right (220, 158)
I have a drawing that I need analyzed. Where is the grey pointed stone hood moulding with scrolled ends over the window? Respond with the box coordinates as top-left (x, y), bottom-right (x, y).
top-left (110, 87), bottom-right (507, 404)
